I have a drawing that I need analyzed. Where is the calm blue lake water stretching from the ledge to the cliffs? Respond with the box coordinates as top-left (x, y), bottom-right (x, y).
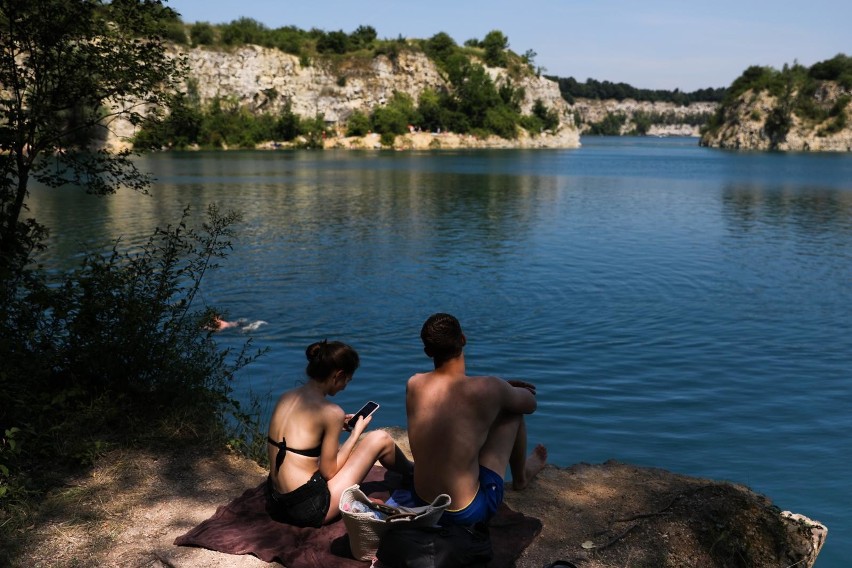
top-left (32, 138), bottom-right (852, 567)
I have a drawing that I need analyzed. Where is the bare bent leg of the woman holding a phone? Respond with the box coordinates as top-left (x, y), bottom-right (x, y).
top-left (325, 430), bottom-right (414, 522)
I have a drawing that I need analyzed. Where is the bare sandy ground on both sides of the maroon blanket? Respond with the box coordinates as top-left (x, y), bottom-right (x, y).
top-left (11, 429), bottom-right (825, 568)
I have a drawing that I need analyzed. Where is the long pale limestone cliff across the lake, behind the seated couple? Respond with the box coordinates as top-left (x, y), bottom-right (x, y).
top-left (105, 45), bottom-right (579, 152)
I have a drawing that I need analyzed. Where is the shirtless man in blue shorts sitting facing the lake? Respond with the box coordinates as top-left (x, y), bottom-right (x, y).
top-left (406, 314), bottom-right (547, 525)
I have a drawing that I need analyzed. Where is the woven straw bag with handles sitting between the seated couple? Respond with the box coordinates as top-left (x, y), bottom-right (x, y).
top-left (339, 484), bottom-right (450, 560)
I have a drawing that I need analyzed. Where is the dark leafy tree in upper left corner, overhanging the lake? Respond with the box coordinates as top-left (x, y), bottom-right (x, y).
top-left (0, 0), bottom-right (180, 276)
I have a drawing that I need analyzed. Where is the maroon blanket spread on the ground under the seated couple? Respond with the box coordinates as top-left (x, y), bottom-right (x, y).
top-left (175, 466), bottom-right (541, 568)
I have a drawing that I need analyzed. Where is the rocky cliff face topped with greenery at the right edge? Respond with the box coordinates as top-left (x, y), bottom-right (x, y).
top-left (701, 81), bottom-right (852, 152)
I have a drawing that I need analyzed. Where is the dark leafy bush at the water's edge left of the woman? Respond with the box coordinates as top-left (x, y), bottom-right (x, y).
top-left (0, 206), bottom-right (260, 496)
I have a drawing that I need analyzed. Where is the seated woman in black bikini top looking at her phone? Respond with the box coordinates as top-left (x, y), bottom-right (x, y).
top-left (266, 341), bottom-right (413, 527)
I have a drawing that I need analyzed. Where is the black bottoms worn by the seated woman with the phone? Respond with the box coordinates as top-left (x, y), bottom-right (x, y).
top-left (266, 472), bottom-right (331, 528)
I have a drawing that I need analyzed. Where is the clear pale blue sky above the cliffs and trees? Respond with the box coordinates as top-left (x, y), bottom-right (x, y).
top-left (167, 0), bottom-right (852, 91)
